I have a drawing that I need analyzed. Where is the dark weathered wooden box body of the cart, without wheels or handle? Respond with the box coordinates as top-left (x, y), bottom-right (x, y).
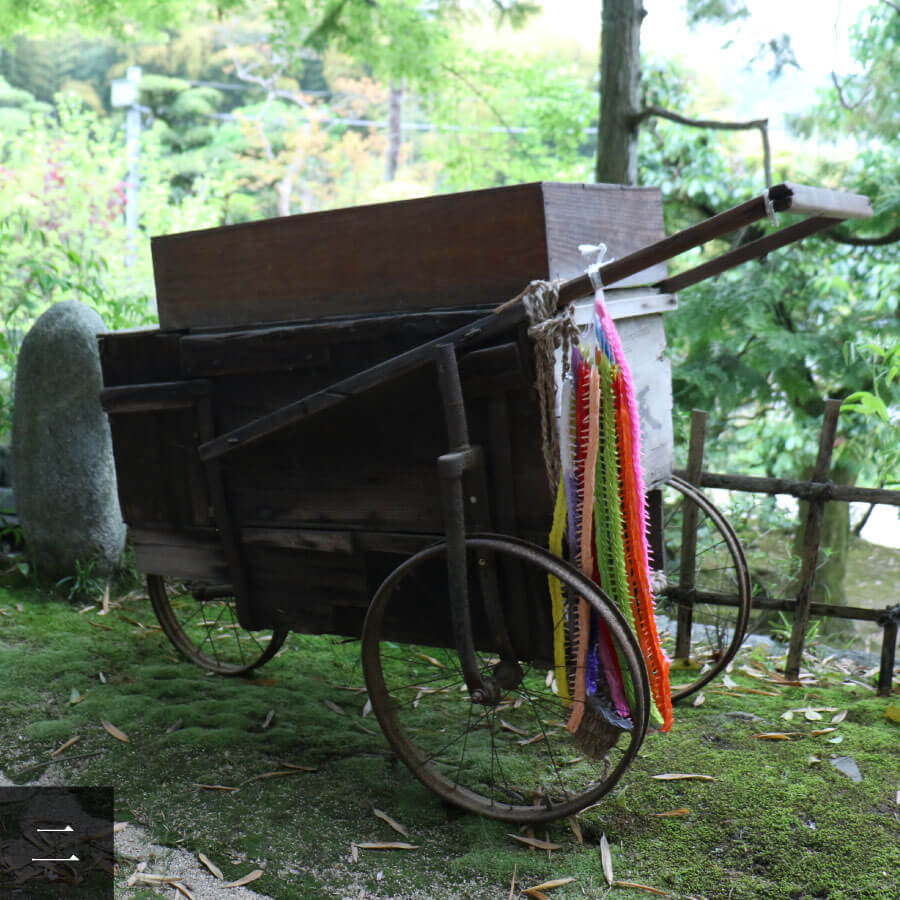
top-left (101, 184), bottom-right (674, 658)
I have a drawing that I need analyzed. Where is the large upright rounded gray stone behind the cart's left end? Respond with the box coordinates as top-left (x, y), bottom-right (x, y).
top-left (12, 300), bottom-right (125, 581)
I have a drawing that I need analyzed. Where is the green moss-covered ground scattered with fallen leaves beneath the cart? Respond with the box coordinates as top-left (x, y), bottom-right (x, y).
top-left (0, 587), bottom-right (900, 900)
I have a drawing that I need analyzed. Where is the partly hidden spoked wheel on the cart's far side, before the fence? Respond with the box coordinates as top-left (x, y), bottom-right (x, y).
top-left (655, 475), bottom-right (751, 700)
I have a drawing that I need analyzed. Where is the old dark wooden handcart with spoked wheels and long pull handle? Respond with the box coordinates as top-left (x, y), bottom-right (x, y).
top-left (100, 184), bottom-right (868, 822)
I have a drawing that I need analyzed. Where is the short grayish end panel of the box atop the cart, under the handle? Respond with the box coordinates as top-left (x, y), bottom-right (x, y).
top-left (543, 183), bottom-right (667, 287)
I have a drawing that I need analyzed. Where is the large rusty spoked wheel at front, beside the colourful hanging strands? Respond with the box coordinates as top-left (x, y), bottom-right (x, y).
top-left (362, 535), bottom-right (649, 822)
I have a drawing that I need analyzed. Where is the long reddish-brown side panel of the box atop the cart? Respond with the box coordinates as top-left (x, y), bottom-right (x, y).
top-left (152, 184), bottom-right (548, 329)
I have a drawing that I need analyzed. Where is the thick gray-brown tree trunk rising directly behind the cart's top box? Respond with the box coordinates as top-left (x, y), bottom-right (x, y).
top-left (597, 0), bottom-right (646, 184)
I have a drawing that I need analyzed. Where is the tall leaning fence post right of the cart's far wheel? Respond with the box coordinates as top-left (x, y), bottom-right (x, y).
top-left (785, 400), bottom-right (841, 679)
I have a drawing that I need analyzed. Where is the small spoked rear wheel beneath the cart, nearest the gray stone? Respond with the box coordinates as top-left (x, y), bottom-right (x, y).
top-left (147, 575), bottom-right (287, 675)
